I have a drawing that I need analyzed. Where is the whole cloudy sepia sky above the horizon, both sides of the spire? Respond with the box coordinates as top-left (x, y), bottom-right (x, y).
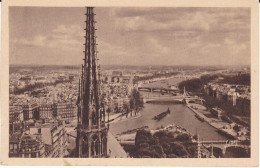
top-left (9, 7), bottom-right (250, 65)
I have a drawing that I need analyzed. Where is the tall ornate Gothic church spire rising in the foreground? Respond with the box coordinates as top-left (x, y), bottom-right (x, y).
top-left (76, 7), bottom-right (108, 158)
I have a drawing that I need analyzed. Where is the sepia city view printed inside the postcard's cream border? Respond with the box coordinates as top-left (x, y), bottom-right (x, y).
top-left (2, 0), bottom-right (258, 165)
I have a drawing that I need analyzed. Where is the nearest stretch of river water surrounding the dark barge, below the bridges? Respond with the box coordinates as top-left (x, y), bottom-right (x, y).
top-left (110, 103), bottom-right (227, 140)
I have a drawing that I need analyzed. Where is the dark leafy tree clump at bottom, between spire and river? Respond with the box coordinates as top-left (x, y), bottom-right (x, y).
top-left (134, 130), bottom-right (197, 158)
